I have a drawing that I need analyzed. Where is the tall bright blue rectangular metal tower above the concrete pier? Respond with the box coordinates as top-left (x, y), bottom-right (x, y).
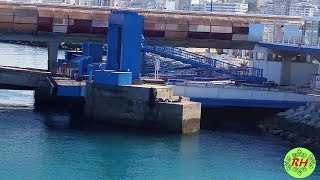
top-left (107, 11), bottom-right (144, 80)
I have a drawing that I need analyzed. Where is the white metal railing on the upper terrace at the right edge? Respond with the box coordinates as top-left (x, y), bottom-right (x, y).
top-left (263, 34), bottom-right (320, 47)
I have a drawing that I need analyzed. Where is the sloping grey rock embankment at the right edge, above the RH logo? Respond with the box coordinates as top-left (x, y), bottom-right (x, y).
top-left (259, 103), bottom-right (320, 149)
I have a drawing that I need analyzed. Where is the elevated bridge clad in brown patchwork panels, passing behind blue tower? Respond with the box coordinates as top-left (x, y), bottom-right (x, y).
top-left (0, 2), bottom-right (302, 47)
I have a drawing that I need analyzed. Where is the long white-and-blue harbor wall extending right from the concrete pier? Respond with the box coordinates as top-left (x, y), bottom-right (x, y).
top-left (173, 83), bottom-right (320, 108)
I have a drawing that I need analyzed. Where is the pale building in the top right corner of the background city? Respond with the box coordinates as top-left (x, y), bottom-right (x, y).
top-left (289, 2), bottom-right (318, 16)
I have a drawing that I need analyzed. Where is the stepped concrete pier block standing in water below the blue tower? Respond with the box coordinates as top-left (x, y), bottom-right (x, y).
top-left (85, 82), bottom-right (201, 133)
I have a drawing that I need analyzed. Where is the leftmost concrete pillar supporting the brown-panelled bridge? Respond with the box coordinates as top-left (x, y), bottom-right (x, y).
top-left (47, 41), bottom-right (59, 74)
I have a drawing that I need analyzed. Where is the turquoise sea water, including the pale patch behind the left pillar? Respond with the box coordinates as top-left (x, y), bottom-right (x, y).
top-left (0, 44), bottom-right (320, 180)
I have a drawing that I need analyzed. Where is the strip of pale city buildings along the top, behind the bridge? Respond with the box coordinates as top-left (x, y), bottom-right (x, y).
top-left (2, 0), bottom-right (320, 16)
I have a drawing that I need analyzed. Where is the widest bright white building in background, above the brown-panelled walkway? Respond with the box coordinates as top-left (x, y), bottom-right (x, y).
top-left (191, 2), bottom-right (248, 14)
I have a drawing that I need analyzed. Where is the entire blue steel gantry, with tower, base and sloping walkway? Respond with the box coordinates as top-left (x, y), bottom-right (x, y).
top-left (56, 11), bottom-right (266, 85)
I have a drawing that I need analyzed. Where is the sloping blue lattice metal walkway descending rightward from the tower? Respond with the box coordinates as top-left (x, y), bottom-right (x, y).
top-left (142, 39), bottom-right (266, 83)
